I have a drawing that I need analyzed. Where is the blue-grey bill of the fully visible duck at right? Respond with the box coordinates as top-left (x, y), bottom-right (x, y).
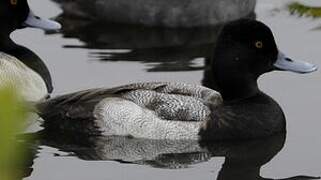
top-left (274, 51), bottom-right (318, 73)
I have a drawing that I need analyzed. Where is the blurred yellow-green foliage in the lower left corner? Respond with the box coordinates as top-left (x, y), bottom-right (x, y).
top-left (0, 88), bottom-right (27, 180)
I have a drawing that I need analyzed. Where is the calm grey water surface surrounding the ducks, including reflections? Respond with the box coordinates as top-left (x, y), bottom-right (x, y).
top-left (13, 0), bottom-right (321, 180)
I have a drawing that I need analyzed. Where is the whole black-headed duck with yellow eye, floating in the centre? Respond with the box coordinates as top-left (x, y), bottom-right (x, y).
top-left (38, 19), bottom-right (317, 140)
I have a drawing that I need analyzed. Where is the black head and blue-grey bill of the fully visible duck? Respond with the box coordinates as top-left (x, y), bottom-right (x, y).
top-left (212, 19), bottom-right (317, 100)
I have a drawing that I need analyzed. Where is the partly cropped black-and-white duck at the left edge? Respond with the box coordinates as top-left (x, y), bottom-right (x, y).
top-left (0, 0), bottom-right (60, 101)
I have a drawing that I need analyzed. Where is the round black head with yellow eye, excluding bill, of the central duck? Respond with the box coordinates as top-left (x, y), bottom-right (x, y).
top-left (215, 19), bottom-right (278, 78)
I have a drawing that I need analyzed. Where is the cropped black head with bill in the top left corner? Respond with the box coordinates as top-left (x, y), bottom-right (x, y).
top-left (0, 0), bottom-right (60, 34)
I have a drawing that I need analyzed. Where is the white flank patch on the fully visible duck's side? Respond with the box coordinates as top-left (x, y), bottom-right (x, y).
top-left (94, 97), bottom-right (201, 140)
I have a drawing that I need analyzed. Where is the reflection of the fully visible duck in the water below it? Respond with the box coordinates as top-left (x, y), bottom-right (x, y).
top-left (29, 131), bottom-right (318, 180)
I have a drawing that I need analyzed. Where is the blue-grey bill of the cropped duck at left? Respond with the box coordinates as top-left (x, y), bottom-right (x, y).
top-left (23, 10), bottom-right (61, 30)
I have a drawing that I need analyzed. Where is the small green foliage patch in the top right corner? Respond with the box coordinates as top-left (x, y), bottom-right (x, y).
top-left (288, 2), bottom-right (321, 18)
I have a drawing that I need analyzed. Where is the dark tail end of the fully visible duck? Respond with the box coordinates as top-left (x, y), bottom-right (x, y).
top-left (33, 90), bottom-right (100, 135)
